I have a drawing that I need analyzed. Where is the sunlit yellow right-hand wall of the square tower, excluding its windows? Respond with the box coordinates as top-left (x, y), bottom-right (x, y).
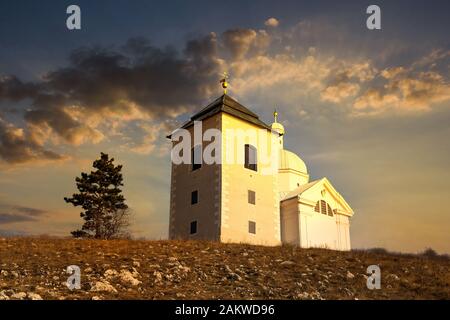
top-left (220, 113), bottom-right (280, 245)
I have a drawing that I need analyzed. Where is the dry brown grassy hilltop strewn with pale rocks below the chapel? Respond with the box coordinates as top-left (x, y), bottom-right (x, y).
top-left (0, 238), bottom-right (450, 300)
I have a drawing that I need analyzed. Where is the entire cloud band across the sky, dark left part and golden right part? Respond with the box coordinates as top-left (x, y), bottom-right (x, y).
top-left (0, 18), bottom-right (450, 164)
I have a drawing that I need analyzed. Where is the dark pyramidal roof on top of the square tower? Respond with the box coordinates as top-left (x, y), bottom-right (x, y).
top-left (182, 94), bottom-right (271, 130)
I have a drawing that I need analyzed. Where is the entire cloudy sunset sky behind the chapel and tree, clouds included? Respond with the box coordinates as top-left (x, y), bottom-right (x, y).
top-left (0, 0), bottom-right (450, 253)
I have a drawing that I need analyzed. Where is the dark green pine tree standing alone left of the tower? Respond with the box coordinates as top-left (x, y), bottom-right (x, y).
top-left (64, 152), bottom-right (128, 239)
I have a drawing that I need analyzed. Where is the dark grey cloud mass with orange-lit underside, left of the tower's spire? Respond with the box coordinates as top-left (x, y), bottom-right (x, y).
top-left (0, 33), bottom-right (222, 163)
